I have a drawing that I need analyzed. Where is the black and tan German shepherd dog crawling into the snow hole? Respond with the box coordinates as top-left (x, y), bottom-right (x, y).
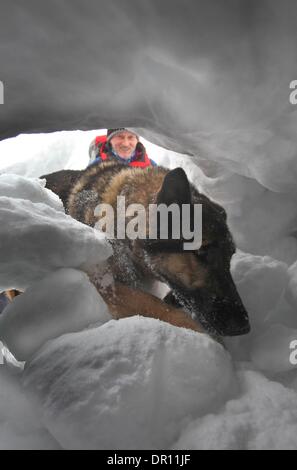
top-left (41, 162), bottom-right (250, 337)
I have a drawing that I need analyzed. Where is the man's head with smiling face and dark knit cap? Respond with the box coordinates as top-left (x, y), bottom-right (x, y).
top-left (107, 127), bottom-right (139, 159)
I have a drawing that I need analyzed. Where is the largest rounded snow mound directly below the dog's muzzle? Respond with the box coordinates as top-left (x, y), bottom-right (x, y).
top-left (24, 317), bottom-right (237, 449)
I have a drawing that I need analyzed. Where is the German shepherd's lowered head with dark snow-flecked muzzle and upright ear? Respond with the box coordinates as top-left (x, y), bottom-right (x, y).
top-left (137, 168), bottom-right (250, 336)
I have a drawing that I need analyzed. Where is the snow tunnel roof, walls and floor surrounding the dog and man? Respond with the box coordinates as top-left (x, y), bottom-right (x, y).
top-left (0, 0), bottom-right (297, 449)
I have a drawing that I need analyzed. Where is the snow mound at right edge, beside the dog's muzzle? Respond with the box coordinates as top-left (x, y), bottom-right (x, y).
top-left (226, 251), bottom-right (297, 366)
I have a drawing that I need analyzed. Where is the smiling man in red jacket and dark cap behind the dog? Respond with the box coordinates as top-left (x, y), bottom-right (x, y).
top-left (89, 127), bottom-right (156, 168)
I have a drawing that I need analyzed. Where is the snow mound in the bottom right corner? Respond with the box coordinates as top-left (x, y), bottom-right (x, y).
top-left (173, 371), bottom-right (297, 450)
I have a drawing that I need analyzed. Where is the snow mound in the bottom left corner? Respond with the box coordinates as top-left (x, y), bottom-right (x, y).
top-left (0, 365), bottom-right (60, 450)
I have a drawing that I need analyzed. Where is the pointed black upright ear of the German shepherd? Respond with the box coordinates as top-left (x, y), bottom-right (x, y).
top-left (157, 168), bottom-right (191, 206)
